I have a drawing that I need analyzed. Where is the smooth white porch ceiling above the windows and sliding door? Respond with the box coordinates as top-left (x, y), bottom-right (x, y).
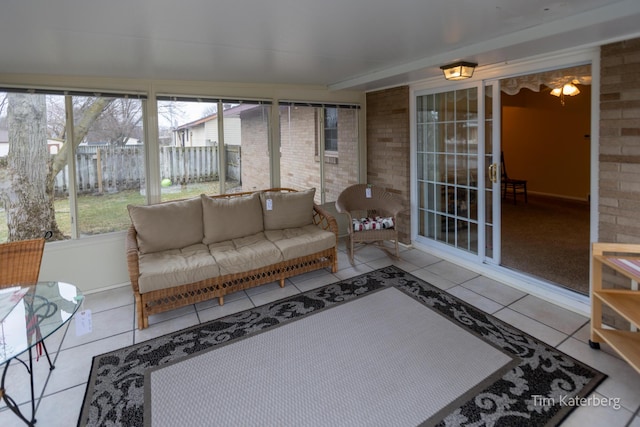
top-left (0, 0), bottom-right (640, 90)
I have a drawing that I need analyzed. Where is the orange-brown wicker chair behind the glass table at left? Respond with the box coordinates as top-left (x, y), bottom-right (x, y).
top-left (0, 233), bottom-right (53, 369)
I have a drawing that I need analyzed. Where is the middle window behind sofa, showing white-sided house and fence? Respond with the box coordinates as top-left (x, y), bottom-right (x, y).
top-left (158, 96), bottom-right (270, 200)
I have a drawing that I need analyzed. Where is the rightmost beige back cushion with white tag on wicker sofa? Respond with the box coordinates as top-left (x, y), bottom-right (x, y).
top-left (260, 188), bottom-right (316, 230)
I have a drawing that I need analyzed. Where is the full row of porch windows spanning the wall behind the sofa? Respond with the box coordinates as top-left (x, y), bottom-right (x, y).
top-left (0, 88), bottom-right (359, 241)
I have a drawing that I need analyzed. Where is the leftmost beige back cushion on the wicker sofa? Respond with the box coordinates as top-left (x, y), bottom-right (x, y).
top-left (127, 197), bottom-right (204, 254)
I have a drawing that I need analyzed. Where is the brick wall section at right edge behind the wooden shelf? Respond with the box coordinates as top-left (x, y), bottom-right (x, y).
top-left (598, 38), bottom-right (640, 328)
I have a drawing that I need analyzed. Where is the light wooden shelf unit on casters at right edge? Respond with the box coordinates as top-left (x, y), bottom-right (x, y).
top-left (589, 243), bottom-right (640, 373)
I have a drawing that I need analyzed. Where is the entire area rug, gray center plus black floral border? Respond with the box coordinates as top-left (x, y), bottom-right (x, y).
top-left (78, 266), bottom-right (605, 426)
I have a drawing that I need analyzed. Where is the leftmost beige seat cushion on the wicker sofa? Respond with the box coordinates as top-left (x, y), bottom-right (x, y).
top-left (138, 243), bottom-right (220, 293)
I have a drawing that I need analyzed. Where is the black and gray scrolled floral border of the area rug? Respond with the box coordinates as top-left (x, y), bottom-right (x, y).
top-left (78, 266), bottom-right (605, 426)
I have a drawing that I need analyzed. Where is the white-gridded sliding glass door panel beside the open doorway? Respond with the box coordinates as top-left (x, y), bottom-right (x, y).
top-left (416, 86), bottom-right (497, 258)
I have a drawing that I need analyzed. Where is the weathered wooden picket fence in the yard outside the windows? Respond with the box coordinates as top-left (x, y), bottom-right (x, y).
top-left (55, 146), bottom-right (241, 194)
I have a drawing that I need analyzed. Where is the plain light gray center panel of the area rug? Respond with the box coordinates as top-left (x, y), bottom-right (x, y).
top-left (145, 288), bottom-right (512, 427)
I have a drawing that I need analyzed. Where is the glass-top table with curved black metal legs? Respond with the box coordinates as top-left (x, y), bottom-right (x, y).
top-left (0, 282), bottom-right (84, 425)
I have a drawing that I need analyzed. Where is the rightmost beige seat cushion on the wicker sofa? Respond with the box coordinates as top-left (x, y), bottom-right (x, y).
top-left (264, 225), bottom-right (336, 261)
